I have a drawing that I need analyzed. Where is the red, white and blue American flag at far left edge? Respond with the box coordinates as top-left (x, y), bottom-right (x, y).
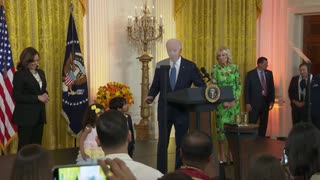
top-left (0, 5), bottom-right (17, 150)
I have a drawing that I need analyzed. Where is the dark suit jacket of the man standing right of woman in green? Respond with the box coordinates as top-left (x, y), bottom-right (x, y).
top-left (245, 69), bottom-right (275, 107)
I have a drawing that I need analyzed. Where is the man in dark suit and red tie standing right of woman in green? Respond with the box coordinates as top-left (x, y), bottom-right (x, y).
top-left (245, 57), bottom-right (275, 136)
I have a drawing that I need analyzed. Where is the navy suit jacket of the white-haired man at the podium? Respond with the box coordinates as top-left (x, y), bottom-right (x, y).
top-left (148, 57), bottom-right (205, 110)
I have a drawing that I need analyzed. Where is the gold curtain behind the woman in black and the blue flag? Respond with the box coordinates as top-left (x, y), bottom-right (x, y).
top-left (4, 0), bottom-right (85, 153)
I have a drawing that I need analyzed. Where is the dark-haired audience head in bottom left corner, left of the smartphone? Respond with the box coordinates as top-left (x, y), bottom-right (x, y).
top-left (10, 144), bottom-right (52, 180)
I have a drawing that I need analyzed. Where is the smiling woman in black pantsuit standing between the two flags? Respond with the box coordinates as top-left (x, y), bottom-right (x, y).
top-left (13, 47), bottom-right (49, 150)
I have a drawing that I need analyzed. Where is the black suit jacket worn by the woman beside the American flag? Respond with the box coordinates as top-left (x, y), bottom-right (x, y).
top-left (13, 69), bottom-right (47, 126)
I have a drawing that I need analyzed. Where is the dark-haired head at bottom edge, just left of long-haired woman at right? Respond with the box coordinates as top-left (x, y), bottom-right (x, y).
top-left (248, 154), bottom-right (287, 180)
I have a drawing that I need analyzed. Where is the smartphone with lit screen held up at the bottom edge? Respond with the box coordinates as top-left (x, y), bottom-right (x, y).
top-left (53, 165), bottom-right (106, 180)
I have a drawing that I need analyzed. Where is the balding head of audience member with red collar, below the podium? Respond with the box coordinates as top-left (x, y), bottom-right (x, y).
top-left (178, 130), bottom-right (213, 180)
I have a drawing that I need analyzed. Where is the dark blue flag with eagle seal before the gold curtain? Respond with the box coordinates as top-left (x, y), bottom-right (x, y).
top-left (62, 13), bottom-right (88, 136)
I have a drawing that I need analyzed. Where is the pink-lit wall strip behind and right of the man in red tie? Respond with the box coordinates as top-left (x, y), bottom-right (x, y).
top-left (257, 0), bottom-right (292, 136)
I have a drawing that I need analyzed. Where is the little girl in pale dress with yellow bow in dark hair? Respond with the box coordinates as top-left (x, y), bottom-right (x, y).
top-left (76, 104), bottom-right (104, 164)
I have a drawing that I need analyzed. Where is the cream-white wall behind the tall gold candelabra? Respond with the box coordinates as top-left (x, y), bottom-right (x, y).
top-left (84, 0), bottom-right (175, 137)
